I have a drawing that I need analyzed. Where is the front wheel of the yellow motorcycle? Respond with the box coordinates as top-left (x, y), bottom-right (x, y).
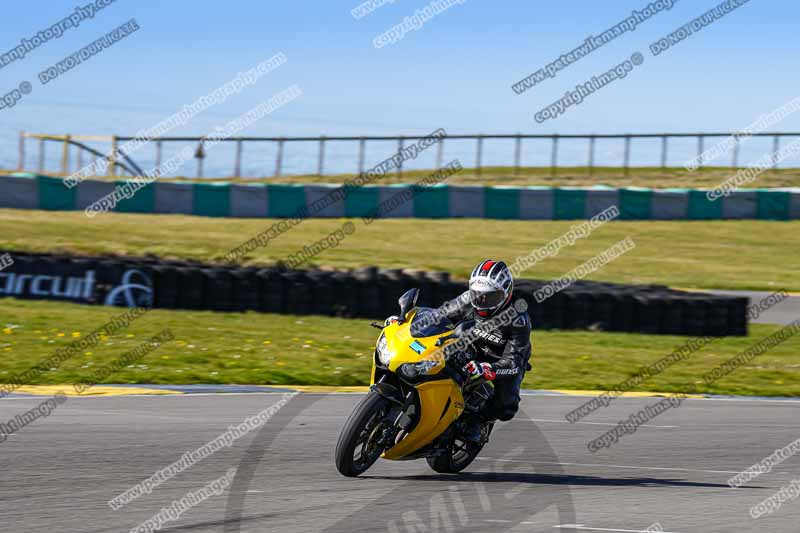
top-left (336, 391), bottom-right (389, 477)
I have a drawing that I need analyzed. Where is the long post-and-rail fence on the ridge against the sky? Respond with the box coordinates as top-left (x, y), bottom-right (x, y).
top-left (18, 131), bottom-right (800, 178)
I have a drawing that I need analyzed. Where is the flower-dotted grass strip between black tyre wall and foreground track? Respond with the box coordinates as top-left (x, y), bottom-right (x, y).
top-left (0, 299), bottom-right (800, 396)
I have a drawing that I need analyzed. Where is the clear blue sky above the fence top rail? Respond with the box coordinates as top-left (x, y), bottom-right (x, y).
top-left (0, 0), bottom-right (800, 170)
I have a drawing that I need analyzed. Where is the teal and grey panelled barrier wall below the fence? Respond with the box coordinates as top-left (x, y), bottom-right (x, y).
top-left (0, 173), bottom-right (800, 220)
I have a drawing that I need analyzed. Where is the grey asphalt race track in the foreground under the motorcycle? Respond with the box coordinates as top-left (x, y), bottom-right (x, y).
top-left (0, 393), bottom-right (800, 533)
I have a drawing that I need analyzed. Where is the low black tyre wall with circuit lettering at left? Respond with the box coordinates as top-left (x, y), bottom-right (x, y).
top-left (0, 251), bottom-right (748, 336)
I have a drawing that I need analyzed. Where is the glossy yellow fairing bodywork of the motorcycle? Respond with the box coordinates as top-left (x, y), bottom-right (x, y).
top-left (372, 310), bottom-right (464, 459)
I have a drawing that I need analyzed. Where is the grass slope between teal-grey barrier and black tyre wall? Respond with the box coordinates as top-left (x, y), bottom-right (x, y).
top-left (0, 209), bottom-right (800, 291)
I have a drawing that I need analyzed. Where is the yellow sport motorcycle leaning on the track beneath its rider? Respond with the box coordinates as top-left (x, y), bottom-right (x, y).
top-left (336, 289), bottom-right (494, 476)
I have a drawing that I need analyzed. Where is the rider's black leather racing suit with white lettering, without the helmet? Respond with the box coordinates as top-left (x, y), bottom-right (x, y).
top-left (441, 292), bottom-right (531, 421)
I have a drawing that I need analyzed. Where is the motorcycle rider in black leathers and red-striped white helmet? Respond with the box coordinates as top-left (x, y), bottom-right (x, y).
top-left (387, 259), bottom-right (531, 442)
